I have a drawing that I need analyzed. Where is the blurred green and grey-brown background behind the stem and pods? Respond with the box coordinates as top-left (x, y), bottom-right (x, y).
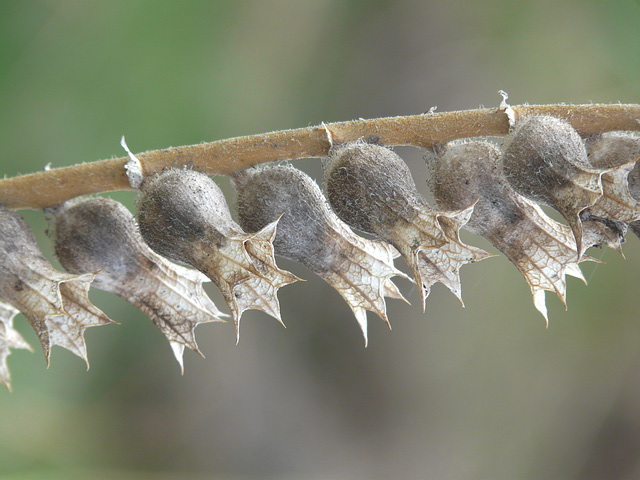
top-left (0, 0), bottom-right (640, 480)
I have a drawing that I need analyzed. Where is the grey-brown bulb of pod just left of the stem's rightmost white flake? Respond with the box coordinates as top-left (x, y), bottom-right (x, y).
top-left (431, 141), bottom-right (523, 235)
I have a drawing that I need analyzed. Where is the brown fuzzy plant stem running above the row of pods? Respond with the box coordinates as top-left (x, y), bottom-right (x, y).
top-left (0, 104), bottom-right (640, 209)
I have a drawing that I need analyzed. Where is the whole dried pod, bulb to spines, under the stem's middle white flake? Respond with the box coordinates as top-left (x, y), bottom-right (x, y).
top-left (324, 142), bottom-right (491, 310)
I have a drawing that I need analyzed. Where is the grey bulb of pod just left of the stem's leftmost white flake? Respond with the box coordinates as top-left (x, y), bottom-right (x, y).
top-left (47, 197), bottom-right (154, 290)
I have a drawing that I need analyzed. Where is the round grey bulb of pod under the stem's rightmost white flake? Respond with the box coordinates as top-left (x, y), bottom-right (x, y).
top-left (502, 115), bottom-right (590, 205)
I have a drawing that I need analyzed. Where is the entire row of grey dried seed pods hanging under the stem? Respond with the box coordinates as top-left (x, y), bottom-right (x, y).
top-left (0, 116), bottom-right (640, 387)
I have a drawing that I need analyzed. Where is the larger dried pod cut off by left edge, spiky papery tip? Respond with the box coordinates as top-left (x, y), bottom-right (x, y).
top-left (0, 207), bottom-right (113, 367)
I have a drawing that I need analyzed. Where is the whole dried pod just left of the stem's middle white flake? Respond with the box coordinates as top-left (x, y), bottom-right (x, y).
top-left (234, 166), bottom-right (406, 344)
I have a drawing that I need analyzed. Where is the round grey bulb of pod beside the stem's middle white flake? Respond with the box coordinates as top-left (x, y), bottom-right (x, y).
top-left (324, 142), bottom-right (425, 238)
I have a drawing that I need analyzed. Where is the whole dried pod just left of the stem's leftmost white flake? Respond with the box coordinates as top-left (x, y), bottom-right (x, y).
top-left (47, 197), bottom-right (222, 371)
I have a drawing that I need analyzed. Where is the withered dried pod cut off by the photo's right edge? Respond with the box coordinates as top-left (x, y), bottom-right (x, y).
top-left (583, 132), bottom-right (640, 254)
